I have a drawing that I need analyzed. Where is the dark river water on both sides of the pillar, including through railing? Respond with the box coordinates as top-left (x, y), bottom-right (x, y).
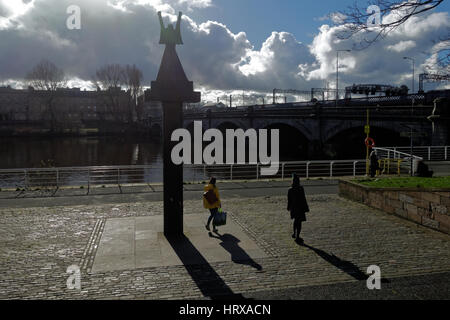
top-left (0, 136), bottom-right (368, 188)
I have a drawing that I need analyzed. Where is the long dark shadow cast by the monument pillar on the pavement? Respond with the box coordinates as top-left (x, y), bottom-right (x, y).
top-left (167, 235), bottom-right (244, 300)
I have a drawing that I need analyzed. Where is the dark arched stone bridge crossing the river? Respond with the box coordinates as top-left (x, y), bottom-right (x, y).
top-left (151, 90), bottom-right (450, 160)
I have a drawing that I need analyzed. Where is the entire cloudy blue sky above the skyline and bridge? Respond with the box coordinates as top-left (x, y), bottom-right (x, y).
top-left (0, 0), bottom-right (450, 100)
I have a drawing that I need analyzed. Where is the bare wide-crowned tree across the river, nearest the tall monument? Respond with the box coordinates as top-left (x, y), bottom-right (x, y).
top-left (93, 64), bottom-right (143, 122)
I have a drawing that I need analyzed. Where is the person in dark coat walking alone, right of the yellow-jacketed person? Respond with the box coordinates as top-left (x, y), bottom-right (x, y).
top-left (287, 174), bottom-right (309, 242)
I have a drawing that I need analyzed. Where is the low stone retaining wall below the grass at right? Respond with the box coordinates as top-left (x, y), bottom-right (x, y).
top-left (339, 180), bottom-right (450, 234)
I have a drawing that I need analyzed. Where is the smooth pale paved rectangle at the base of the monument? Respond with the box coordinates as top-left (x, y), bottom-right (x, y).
top-left (92, 214), bottom-right (267, 273)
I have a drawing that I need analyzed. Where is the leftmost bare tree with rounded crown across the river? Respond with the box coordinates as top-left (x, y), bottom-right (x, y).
top-left (25, 59), bottom-right (67, 131)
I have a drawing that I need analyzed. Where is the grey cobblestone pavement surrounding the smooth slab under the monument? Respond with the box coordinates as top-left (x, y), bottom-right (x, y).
top-left (0, 195), bottom-right (450, 299)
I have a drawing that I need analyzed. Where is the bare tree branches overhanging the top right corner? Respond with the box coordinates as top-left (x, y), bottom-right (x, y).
top-left (335, 0), bottom-right (450, 71)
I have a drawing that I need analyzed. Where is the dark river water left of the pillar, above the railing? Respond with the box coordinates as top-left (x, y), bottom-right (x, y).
top-left (0, 136), bottom-right (162, 169)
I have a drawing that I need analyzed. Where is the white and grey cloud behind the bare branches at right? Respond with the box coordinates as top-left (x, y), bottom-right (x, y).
top-left (308, 12), bottom-right (450, 88)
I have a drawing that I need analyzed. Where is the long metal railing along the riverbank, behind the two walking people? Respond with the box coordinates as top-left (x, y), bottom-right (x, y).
top-left (0, 160), bottom-right (366, 193)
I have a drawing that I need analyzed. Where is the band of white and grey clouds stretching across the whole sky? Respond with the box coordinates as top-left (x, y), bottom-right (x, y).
top-left (0, 0), bottom-right (450, 94)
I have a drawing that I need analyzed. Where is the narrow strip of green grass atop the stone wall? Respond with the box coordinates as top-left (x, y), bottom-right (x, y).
top-left (352, 177), bottom-right (450, 189)
